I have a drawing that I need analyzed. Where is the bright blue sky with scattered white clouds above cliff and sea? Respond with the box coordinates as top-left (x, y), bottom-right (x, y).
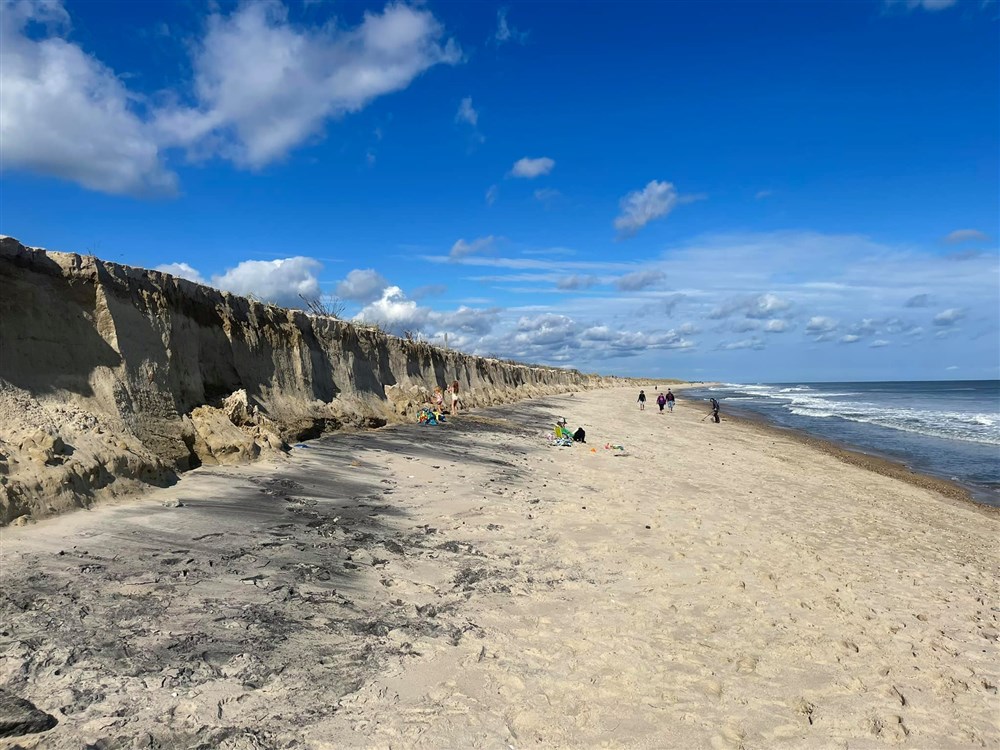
top-left (0, 0), bottom-right (1000, 383)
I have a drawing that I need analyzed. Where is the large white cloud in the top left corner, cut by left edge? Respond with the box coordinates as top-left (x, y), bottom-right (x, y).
top-left (0, 0), bottom-right (177, 196)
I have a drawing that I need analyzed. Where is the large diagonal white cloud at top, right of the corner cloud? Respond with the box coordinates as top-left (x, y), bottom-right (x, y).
top-left (155, 2), bottom-right (461, 168)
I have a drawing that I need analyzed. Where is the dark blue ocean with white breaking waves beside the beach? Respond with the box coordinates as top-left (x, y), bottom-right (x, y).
top-left (681, 380), bottom-right (1000, 507)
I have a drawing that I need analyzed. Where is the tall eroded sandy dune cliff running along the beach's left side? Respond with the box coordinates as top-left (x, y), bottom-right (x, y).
top-left (0, 237), bottom-right (611, 524)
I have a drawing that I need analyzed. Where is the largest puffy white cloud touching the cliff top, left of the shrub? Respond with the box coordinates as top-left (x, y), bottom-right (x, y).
top-left (212, 256), bottom-right (323, 307)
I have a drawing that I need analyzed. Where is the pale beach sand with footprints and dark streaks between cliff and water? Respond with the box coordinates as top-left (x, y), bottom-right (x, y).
top-left (0, 388), bottom-right (1000, 750)
